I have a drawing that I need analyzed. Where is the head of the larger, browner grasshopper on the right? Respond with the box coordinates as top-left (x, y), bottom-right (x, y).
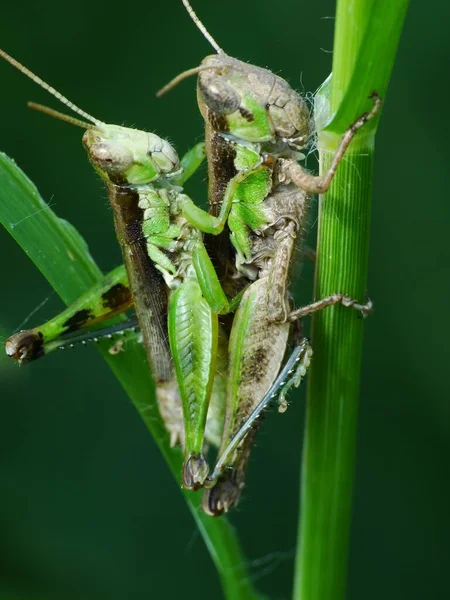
top-left (197, 54), bottom-right (310, 149)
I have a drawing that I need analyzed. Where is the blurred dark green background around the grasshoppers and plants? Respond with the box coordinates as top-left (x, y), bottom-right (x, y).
top-left (0, 0), bottom-right (450, 600)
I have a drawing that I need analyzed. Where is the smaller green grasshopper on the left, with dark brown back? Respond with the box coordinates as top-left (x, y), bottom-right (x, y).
top-left (0, 51), bottom-right (253, 489)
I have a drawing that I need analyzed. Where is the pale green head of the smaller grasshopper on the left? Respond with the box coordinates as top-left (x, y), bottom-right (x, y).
top-left (83, 124), bottom-right (180, 185)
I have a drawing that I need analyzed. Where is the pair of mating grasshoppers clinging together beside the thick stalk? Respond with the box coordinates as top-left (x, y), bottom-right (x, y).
top-left (2, 0), bottom-right (379, 515)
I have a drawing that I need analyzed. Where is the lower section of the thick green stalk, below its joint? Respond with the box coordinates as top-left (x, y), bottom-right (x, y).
top-left (294, 140), bottom-right (373, 600)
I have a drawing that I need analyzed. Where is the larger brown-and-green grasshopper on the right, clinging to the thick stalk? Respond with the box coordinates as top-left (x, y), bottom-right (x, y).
top-left (158, 0), bottom-right (380, 515)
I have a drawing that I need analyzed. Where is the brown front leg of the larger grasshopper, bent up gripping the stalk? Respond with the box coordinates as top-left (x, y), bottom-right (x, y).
top-left (279, 92), bottom-right (382, 194)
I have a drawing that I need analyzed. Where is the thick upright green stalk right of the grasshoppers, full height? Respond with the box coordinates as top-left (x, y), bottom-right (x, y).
top-left (293, 0), bottom-right (407, 600)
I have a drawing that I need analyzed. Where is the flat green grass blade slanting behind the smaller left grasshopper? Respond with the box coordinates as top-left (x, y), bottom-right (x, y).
top-left (0, 153), bottom-right (258, 600)
